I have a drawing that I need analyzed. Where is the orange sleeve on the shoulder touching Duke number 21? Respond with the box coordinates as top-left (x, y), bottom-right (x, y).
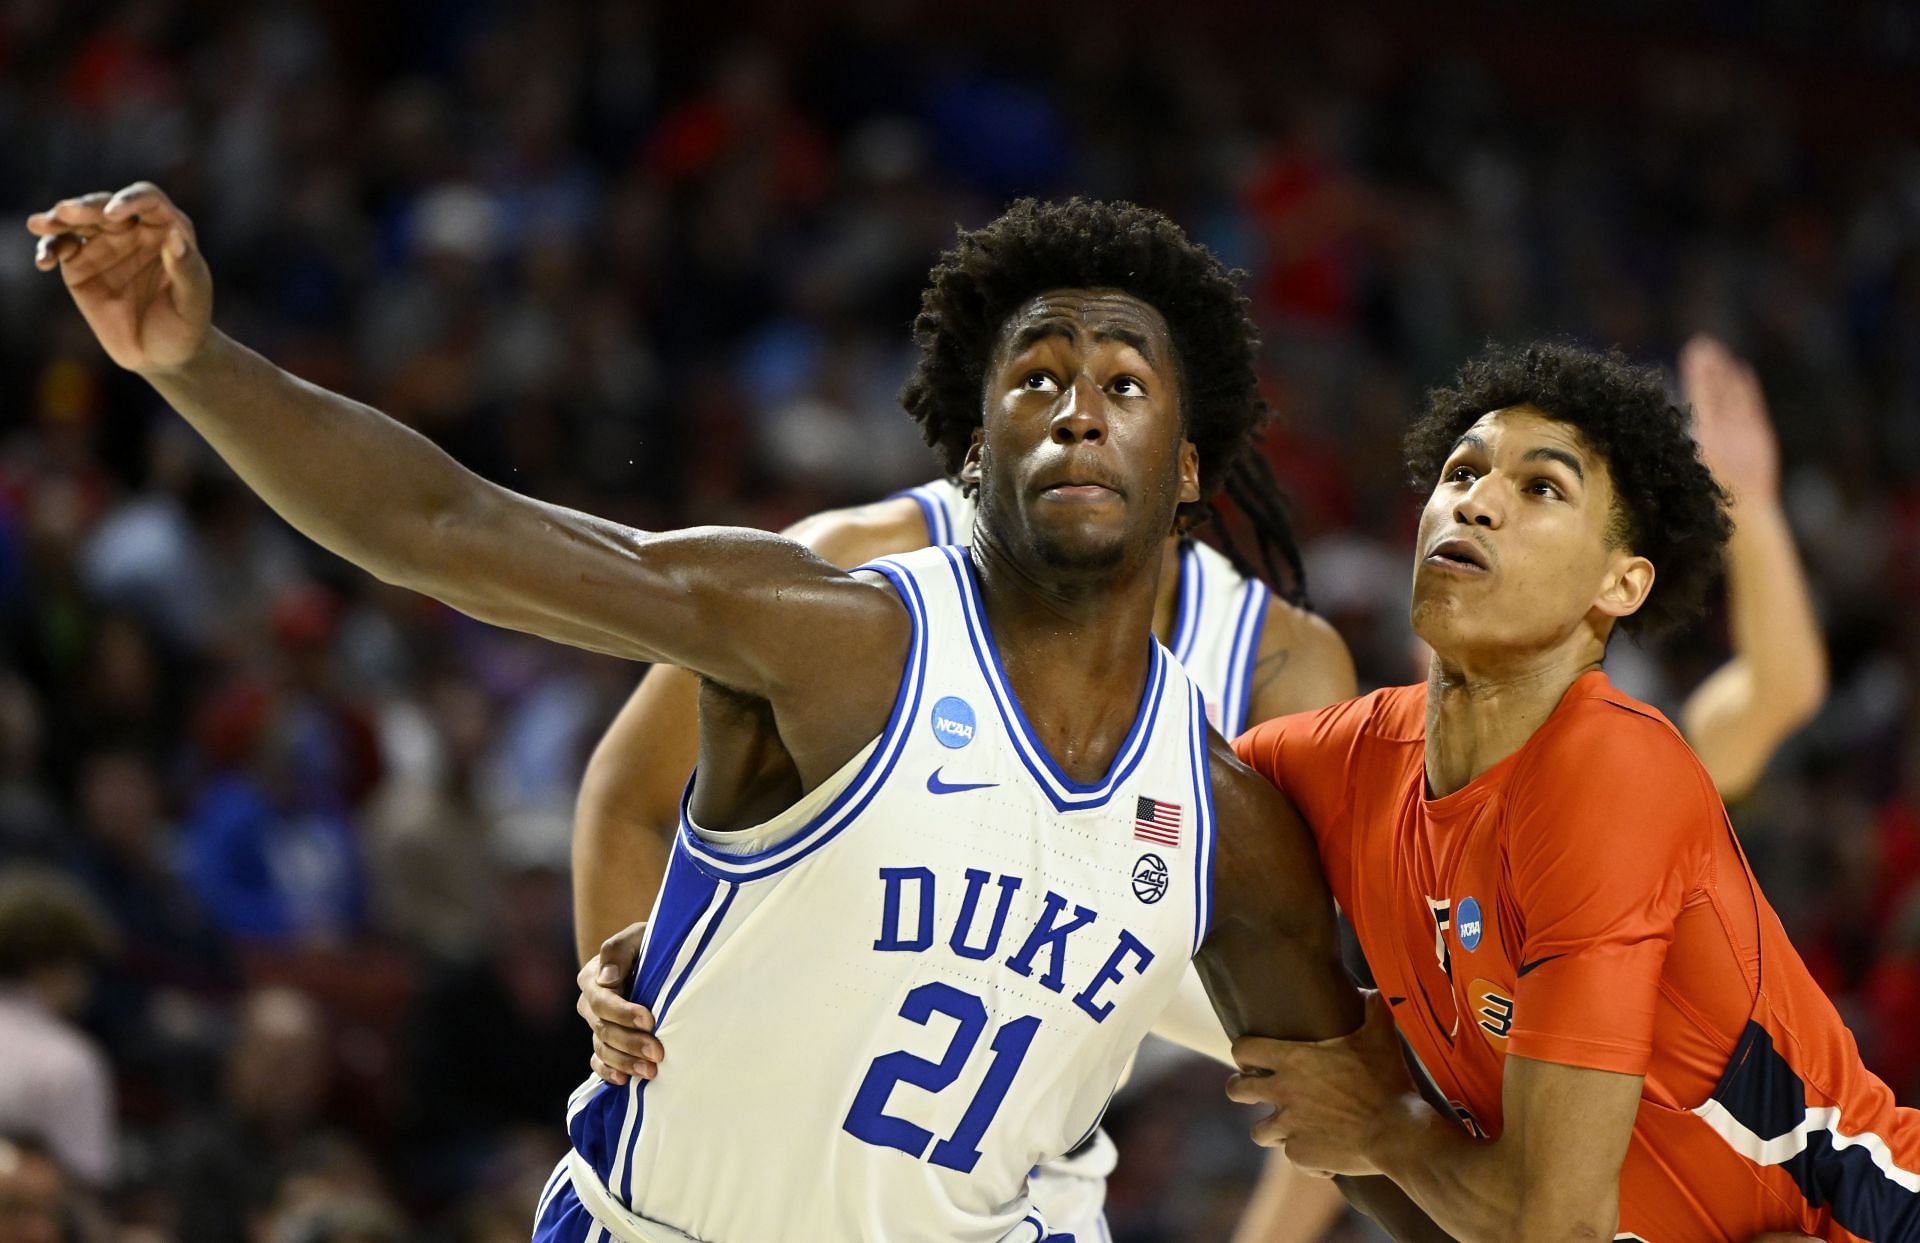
top-left (1233, 695), bottom-right (1371, 907)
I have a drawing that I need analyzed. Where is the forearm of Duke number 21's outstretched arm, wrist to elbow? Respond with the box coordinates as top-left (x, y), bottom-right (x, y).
top-left (148, 330), bottom-right (486, 586)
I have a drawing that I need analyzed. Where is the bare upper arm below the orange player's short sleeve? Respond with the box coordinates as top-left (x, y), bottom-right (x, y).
top-left (1500, 1055), bottom-right (1642, 1239)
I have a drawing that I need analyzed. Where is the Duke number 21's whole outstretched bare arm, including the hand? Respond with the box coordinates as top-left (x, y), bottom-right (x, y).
top-left (29, 183), bottom-right (910, 745)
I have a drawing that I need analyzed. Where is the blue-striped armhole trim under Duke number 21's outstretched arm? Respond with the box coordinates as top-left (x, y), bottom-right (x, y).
top-left (680, 559), bottom-right (927, 884)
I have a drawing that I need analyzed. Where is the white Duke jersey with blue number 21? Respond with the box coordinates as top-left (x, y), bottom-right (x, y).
top-left (568, 548), bottom-right (1213, 1243)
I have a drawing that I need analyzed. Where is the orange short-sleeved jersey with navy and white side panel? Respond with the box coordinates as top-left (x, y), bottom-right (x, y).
top-left (1235, 672), bottom-right (1920, 1243)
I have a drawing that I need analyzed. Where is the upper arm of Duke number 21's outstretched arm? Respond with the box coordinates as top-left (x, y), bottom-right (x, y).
top-left (428, 486), bottom-right (910, 695)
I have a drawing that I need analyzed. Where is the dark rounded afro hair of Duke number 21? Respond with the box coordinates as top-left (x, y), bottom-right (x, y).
top-left (900, 198), bottom-right (1292, 546)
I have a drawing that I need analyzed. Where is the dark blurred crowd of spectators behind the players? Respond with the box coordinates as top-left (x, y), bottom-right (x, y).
top-left (0, 0), bottom-right (1920, 1243)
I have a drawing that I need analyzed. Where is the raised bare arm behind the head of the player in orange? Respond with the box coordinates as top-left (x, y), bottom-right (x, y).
top-left (1680, 336), bottom-right (1826, 799)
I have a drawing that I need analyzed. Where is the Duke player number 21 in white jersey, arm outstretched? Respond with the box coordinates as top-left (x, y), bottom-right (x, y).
top-left (29, 183), bottom-right (1432, 1243)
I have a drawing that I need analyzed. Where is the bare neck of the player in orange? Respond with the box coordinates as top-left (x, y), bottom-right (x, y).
top-left (1427, 642), bottom-right (1605, 799)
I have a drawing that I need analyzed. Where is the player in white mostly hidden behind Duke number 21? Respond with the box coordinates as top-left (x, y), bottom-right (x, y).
top-left (574, 453), bottom-right (1354, 1239)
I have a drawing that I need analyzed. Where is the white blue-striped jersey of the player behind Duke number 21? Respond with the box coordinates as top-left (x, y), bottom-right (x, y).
top-left (899, 478), bottom-right (1273, 738)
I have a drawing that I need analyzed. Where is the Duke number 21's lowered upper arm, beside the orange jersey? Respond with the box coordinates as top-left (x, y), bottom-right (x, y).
top-left (1194, 736), bottom-right (1361, 1039)
